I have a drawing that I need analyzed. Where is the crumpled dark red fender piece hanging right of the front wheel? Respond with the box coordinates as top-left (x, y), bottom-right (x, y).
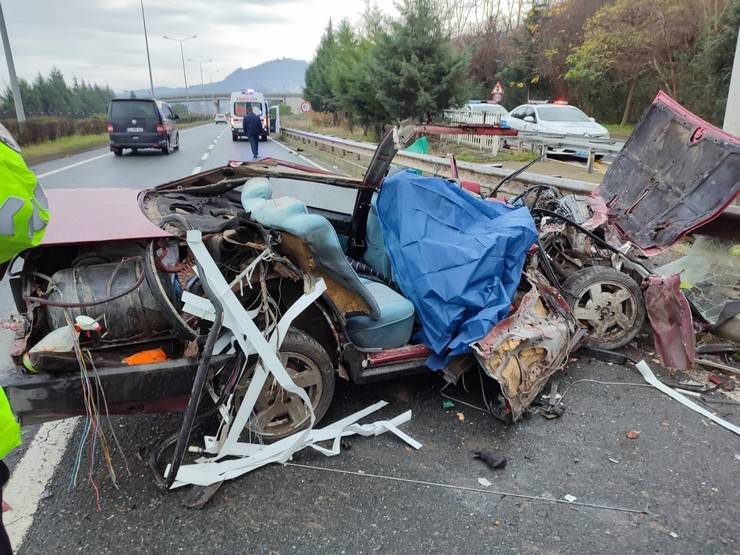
top-left (643, 274), bottom-right (696, 370)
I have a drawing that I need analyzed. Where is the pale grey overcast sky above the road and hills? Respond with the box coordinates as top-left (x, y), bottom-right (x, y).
top-left (0, 0), bottom-right (393, 91)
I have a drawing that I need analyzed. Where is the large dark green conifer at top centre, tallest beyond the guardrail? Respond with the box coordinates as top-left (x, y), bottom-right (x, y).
top-left (368, 0), bottom-right (467, 122)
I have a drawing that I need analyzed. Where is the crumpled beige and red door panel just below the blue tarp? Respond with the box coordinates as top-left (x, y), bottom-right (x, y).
top-left (472, 271), bottom-right (585, 422)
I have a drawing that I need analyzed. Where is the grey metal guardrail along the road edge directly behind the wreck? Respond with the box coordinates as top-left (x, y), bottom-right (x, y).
top-left (280, 127), bottom-right (740, 219)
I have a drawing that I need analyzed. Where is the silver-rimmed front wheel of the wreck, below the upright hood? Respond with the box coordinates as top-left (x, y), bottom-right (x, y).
top-left (563, 266), bottom-right (645, 350)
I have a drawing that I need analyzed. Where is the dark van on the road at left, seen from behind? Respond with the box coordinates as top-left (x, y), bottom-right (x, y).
top-left (108, 98), bottom-right (180, 156)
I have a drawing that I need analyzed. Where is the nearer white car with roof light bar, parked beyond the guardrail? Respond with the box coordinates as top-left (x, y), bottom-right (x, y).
top-left (504, 102), bottom-right (609, 158)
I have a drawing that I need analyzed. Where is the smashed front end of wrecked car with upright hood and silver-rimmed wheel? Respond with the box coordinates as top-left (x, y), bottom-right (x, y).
top-left (528, 92), bottom-right (740, 360)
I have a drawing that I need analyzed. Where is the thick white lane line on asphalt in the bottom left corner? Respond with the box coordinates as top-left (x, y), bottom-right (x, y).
top-left (3, 418), bottom-right (79, 552)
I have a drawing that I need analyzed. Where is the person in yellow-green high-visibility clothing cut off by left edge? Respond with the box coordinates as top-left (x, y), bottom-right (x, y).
top-left (0, 124), bottom-right (49, 554)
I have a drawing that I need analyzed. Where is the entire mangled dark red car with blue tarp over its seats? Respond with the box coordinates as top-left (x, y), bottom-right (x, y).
top-left (2, 90), bottom-right (740, 452)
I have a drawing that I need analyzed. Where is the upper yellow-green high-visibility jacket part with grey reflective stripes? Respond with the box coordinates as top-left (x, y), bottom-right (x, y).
top-left (0, 142), bottom-right (49, 264)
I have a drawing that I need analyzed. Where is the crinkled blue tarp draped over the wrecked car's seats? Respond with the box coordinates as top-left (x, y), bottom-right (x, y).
top-left (378, 171), bottom-right (537, 368)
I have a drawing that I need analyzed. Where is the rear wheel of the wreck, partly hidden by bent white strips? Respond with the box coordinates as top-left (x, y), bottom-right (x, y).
top-left (236, 328), bottom-right (336, 441)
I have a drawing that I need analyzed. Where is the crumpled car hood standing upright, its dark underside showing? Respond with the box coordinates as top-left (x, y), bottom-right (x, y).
top-left (595, 91), bottom-right (740, 254)
